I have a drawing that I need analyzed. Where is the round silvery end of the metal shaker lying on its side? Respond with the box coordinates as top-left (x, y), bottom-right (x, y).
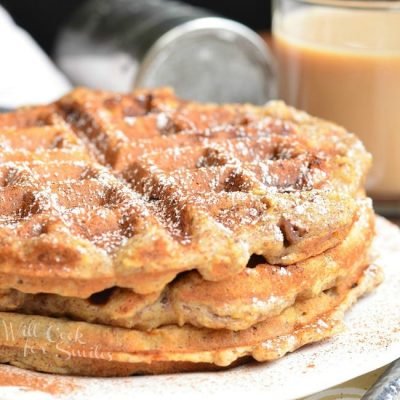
top-left (134, 17), bottom-right (275, 104)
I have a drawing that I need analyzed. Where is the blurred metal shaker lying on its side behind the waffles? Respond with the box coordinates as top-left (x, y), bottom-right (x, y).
top-left (55, 0), bottom-right (275, 104)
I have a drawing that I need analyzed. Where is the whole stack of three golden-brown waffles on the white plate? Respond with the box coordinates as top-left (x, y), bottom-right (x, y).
top-left (0, 88), bottom-right (381, 376)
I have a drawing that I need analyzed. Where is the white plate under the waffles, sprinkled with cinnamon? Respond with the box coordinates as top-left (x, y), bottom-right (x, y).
top-left (0, 218), bottom-right (400, 400)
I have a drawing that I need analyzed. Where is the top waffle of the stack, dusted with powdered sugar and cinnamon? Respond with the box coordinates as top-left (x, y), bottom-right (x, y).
top-left (0, 89), bottom-right (370, 297)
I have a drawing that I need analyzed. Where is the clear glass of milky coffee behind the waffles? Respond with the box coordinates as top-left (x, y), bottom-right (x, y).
top-left (273, 0), bottom-right (400, 215)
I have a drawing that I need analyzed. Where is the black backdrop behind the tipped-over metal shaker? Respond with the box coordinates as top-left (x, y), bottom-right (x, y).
top-left (0, 0), bottom-right (271, 53)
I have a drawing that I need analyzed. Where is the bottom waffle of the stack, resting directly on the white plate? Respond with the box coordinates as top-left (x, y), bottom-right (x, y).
top-left (0, 265), bottom-right (381, 376)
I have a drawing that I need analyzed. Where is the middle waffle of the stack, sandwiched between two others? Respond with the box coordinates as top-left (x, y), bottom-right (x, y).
top-left (0, 199), bottom-right (374, 330)
